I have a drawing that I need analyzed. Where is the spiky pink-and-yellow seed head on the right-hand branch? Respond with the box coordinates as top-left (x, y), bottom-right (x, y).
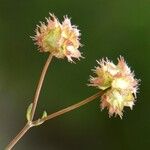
top-left (90, 57), bottom-right (138, 118)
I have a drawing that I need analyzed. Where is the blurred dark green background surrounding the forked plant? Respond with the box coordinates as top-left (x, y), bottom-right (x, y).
top-left (0, 0), bottom-right (150, 150)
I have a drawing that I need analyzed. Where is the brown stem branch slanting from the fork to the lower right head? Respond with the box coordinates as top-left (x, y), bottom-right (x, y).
top-left (32, 91), bottom-right (104, 126)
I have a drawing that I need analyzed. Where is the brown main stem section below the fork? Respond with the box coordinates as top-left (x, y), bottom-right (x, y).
top-left (5, 123), bottom-right (31, 150)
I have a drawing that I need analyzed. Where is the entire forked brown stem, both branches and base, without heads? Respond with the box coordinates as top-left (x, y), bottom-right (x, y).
top-left (5, 54), bottom-right (105, 150)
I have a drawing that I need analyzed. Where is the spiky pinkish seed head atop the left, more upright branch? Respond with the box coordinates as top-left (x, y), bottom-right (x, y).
top-left (34, 14), bottom-right (82, 62)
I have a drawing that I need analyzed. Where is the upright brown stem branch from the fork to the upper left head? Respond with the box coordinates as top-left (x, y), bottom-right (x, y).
top-left (31, 54), bottom-right (53, 121)
